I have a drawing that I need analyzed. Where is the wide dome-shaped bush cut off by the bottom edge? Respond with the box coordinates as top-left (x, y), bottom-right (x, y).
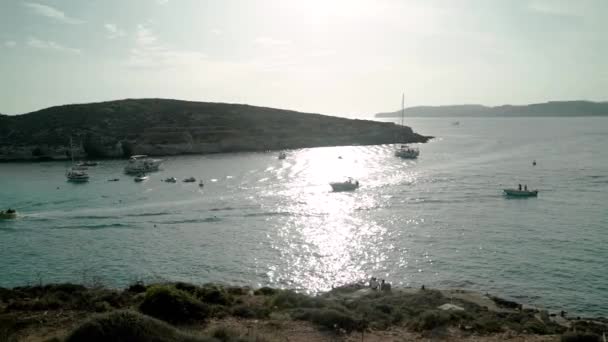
top-left (65, 311), bottom-right (213, 342)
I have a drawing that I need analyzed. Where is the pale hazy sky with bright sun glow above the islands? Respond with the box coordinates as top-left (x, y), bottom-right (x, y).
top-left (0, 0), bottom-right (608, 117)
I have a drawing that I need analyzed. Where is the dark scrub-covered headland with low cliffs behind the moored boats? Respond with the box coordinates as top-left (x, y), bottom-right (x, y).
top-left (0, 99), bottom-right (430, 161)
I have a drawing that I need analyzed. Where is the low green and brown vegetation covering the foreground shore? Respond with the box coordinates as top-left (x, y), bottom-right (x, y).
top-left (0, 283), bottom-right (606, 341)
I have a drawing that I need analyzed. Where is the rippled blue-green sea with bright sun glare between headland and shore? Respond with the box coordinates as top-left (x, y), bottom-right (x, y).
top-left (0, 118), bottom-right (608, 315)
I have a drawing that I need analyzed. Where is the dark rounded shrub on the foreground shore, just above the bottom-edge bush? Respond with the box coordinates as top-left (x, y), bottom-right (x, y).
top-left (139, 285), bottom-right (209, 323)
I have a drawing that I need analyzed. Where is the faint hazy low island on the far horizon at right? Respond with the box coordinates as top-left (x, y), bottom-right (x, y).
top-left (375, 101), bottom-right (608, 118)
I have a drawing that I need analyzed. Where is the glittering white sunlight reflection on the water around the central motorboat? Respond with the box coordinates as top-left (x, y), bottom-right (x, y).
top-left (268, 147), bottom-right (406, 292)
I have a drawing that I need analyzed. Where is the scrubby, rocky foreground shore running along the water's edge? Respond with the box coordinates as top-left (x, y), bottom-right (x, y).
top-left (0, 283), bottom-right (608, 341)
